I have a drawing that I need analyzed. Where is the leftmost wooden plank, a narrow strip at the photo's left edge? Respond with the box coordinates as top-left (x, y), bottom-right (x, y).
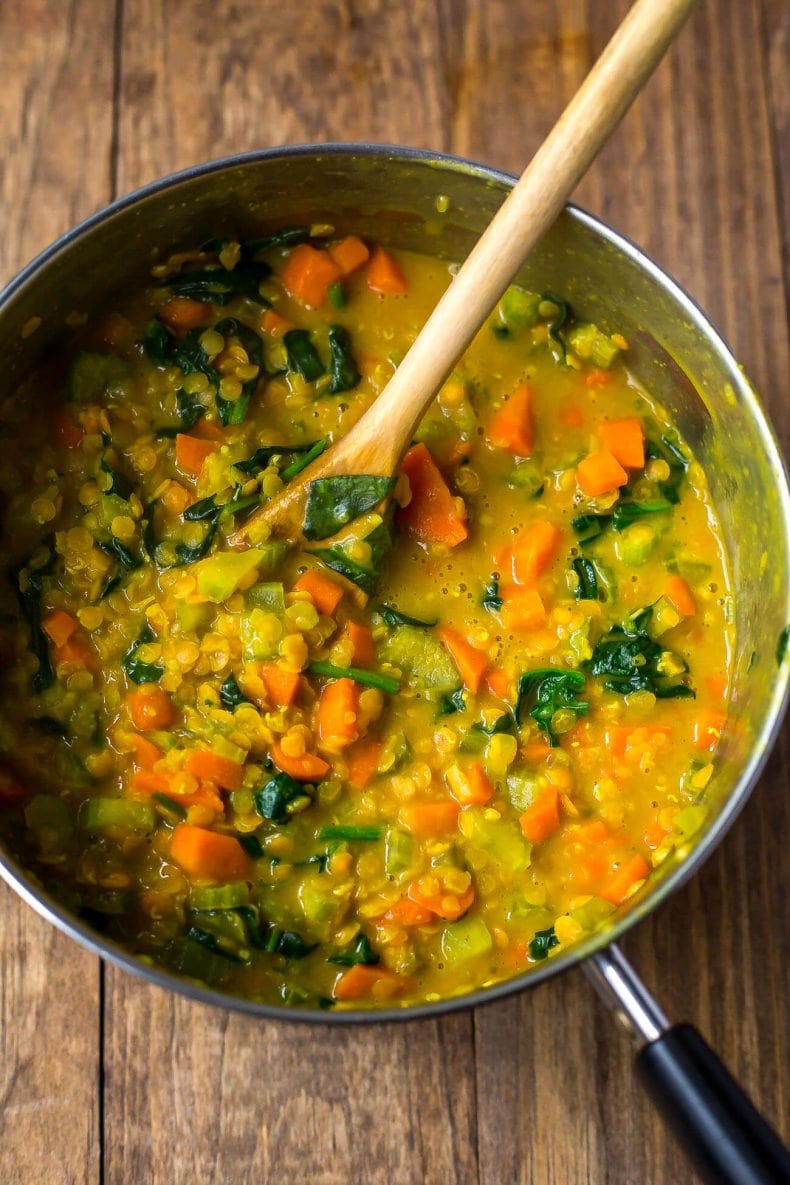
top-left (0, 0), bottom-right (114, 1185)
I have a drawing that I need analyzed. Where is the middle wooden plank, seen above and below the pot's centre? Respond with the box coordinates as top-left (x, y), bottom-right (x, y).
top-left (105, 0), bottom-right (477, 1185)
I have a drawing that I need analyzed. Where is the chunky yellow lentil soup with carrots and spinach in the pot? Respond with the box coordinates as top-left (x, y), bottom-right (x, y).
top-left (0, 226), bottom-right (732, 1010)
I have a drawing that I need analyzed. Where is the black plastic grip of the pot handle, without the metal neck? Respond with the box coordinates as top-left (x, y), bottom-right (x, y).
top-left (636, 1025), bottom-right (790, 1185)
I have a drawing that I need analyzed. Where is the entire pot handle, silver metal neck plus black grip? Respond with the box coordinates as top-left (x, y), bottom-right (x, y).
top-left (584, 946), bottom-right (790, 1185)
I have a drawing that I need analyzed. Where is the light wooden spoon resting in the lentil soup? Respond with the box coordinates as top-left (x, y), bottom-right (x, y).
top-left (231, 0), bottom-right (696, 546)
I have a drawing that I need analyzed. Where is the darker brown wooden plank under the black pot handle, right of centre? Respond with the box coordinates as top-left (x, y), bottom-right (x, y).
top-left (473, 0), bottom-right (790, 1185)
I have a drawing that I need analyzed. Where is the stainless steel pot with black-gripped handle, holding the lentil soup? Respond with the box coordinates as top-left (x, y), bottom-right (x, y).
top-left (0, 145), bottom-right (790, 1185)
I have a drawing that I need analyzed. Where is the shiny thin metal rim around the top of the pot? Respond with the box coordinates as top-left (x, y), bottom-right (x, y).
top-left (0, 141), bottom-right (790, 1025)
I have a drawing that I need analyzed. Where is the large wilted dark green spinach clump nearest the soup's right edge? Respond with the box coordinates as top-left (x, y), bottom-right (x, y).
top-left (585, 607), bottom-right (694, 699)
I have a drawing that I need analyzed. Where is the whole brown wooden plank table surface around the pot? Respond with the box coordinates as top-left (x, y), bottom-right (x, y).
top-left (0, 0), bottom-right (790, 1185)
